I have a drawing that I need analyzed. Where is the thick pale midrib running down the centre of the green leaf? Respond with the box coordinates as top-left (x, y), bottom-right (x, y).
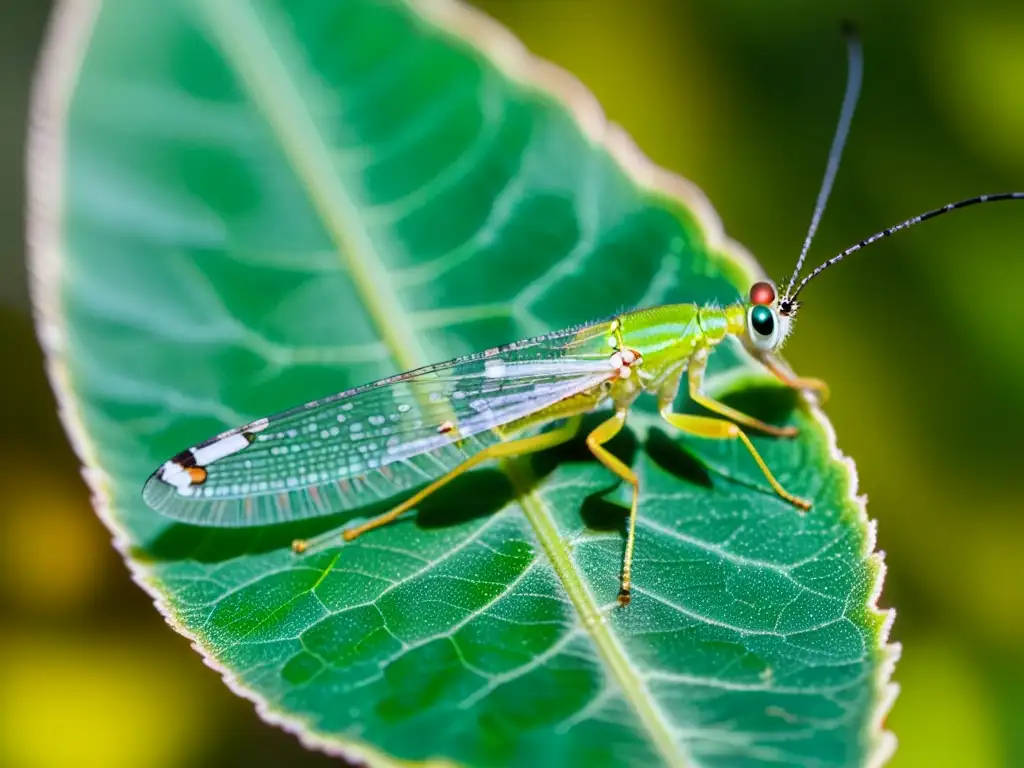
top-left (197, 0), bottom-right (686, 766)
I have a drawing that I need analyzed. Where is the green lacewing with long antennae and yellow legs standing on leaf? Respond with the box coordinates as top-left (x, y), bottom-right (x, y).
top-left (142, 30), bottom-right (1024, 604)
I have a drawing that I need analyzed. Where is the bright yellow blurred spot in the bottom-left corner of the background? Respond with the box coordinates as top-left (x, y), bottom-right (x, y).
top-left (0, 634), bottom-right (208, 768)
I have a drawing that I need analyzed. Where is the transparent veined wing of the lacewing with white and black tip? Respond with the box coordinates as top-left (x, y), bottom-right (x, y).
top-left (142, 322), bottom-right (615, 526)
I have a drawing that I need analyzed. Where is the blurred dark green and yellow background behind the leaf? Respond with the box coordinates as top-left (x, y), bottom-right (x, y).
top-left (0, 0), bottom-right (1024, 766)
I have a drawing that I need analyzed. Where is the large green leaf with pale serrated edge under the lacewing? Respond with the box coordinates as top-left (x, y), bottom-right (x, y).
top-left (30, 0), bottom-right (895, 766)
